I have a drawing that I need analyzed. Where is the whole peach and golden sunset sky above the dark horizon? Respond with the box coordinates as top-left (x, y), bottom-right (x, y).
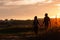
top-left (0, 0), bottom-right (60, 20)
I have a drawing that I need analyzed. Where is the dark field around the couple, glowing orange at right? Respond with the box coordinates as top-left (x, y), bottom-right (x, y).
top-left (0, 19), bottom-right (60, 40)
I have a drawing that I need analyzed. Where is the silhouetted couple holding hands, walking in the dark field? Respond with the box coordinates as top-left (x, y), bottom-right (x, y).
top-left (33, 13), bottom-right (50, 34)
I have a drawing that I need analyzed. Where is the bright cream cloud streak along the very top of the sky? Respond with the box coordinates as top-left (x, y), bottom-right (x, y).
top-left (1, 0), bottom-right (52, 5)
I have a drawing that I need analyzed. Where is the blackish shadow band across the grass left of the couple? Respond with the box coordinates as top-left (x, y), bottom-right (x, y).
top-left (0, 28), bottom-right (32, 34)
